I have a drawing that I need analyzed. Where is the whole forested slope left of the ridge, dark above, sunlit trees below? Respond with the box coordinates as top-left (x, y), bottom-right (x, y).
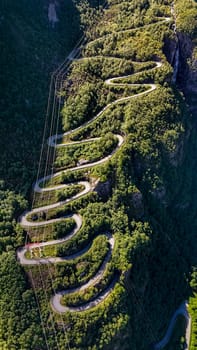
top-left (0, 0), bottom-right (81, 350)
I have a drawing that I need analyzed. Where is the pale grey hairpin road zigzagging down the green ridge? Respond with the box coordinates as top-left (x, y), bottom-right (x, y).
top-left (17, 14), bottom-right (172, 314)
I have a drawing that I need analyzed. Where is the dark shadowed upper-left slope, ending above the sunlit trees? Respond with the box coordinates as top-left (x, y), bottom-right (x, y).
top-left (0, 0), bottom-right (80, 192)
